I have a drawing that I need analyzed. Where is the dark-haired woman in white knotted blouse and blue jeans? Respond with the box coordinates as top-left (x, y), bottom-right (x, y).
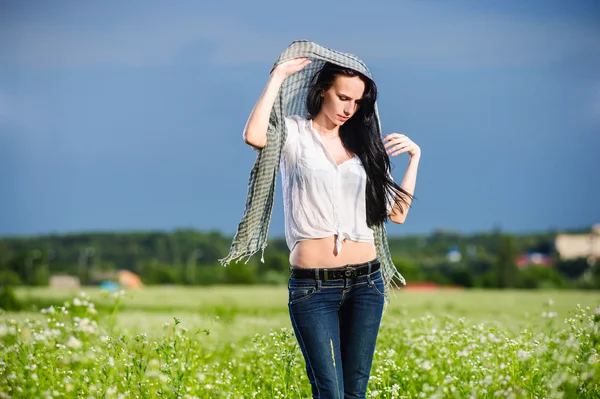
top-left (244, 57), bottom-right (421, 399)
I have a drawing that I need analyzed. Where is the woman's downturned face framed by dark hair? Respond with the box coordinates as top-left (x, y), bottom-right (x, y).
top-left (321, 75), bottom-right (365, 126)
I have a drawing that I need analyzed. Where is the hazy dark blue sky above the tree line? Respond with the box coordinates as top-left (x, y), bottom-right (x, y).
top-left (0, 0), bottom-right (600, 236)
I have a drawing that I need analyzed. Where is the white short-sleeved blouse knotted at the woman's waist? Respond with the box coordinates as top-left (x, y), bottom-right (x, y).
top-left (280, 115), bottom-right (394, 254)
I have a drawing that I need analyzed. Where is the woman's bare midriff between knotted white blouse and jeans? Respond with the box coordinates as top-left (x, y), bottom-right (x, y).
top-left (290, 235), bottom-right (377, 268)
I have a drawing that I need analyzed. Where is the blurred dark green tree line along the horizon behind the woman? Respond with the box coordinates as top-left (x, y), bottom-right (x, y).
top-left (0, 229), bottom-right (600, 289)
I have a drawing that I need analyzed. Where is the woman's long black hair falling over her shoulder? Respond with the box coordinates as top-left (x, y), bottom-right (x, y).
top-left (306, 62), bottom-right (413, 227)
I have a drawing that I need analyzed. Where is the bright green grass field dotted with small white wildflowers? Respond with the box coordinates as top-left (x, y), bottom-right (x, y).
top-left (0, 286), bottom-right (600, 399)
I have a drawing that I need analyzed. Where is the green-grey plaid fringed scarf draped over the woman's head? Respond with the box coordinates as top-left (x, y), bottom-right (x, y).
top-left (219, 40), bottom-right (406, 307)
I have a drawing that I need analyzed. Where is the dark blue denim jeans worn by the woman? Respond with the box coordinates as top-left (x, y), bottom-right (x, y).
top-left (288, 265), bottom-right (384, 399)
